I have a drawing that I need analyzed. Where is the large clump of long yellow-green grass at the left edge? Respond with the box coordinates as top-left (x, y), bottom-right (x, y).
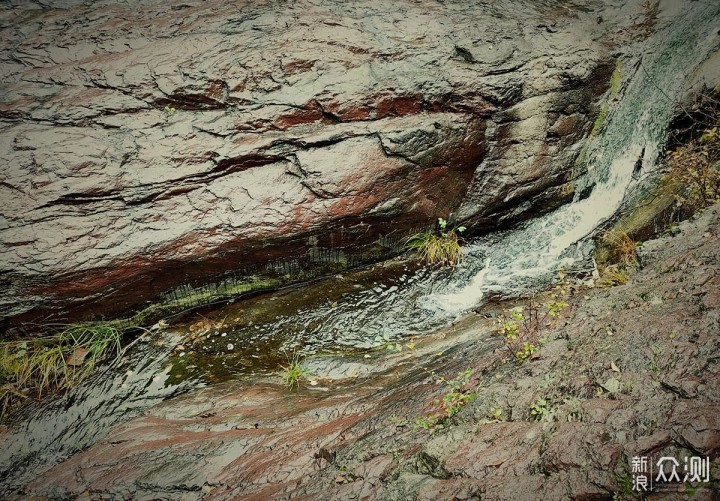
top-left (0, 322), bottom-right (122, 415)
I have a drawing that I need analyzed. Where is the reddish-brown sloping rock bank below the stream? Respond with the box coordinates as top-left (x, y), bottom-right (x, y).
top-left (5, 202), bottom-right (720, 499)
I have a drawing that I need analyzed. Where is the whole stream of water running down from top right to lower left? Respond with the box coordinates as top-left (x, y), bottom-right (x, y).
top-left (0, 3), bottom-right (720, 489)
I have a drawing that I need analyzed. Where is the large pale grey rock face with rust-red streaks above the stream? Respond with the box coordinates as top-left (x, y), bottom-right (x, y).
top-left (0, 0), bottom-right (624, 323)
